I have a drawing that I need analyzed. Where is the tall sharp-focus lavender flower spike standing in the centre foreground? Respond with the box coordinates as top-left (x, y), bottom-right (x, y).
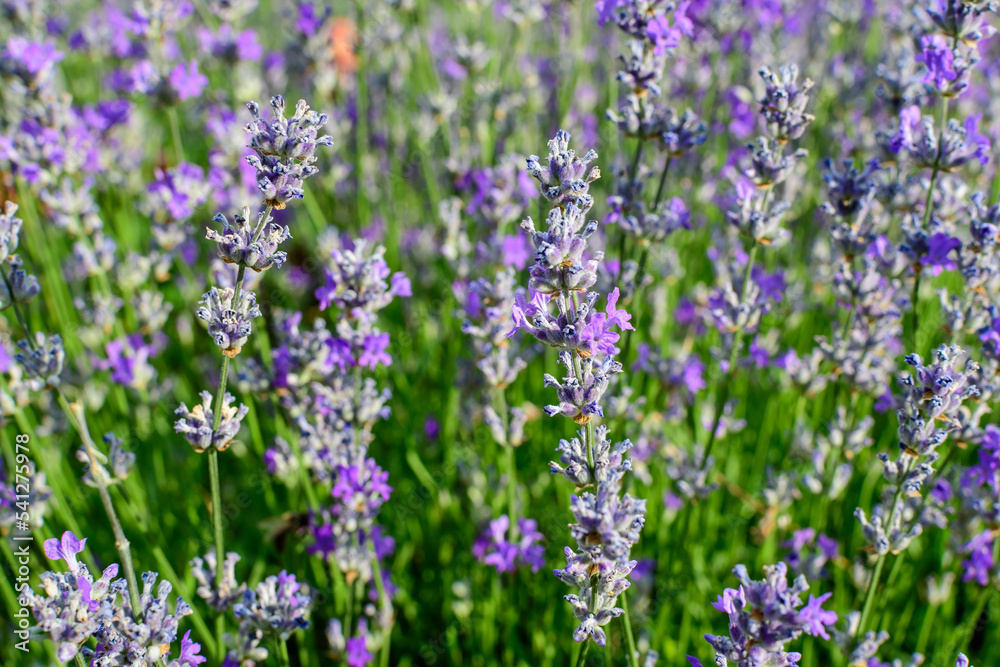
top-left (508, 131), bottom-right (646, 645)
